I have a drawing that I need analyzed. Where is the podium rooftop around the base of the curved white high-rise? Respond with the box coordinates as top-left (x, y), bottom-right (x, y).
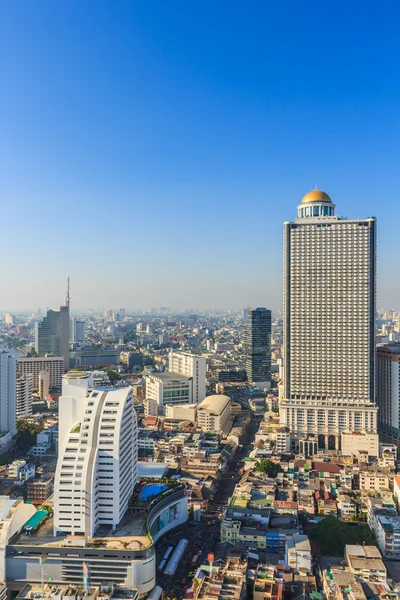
top-left (10, 512), bottom-right (151, 550)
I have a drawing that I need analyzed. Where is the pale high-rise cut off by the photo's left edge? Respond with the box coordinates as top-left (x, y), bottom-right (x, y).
top-left (0, 350), bottom-right (17, 435)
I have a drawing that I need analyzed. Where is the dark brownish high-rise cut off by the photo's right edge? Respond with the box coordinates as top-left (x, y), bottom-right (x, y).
top-left (376, 344), bottom-right (400, 450)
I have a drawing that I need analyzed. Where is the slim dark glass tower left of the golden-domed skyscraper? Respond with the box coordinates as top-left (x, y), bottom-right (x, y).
top-left (244, 308), bottom-right (271, 388)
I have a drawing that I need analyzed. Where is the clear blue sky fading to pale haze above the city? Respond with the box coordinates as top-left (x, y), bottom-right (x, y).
top-left (0, 0), bottom-right (400, 310)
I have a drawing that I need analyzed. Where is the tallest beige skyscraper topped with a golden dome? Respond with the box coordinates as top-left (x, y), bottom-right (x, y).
top-left (280, 189), bottom-right (377, 451)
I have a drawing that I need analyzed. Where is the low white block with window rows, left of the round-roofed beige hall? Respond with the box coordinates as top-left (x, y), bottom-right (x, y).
top-left (145, 373), bottom-right (193, 415)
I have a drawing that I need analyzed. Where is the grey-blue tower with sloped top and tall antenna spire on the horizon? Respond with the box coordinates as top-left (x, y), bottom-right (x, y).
top-left (35, 278), bottom-right (70, 369)
